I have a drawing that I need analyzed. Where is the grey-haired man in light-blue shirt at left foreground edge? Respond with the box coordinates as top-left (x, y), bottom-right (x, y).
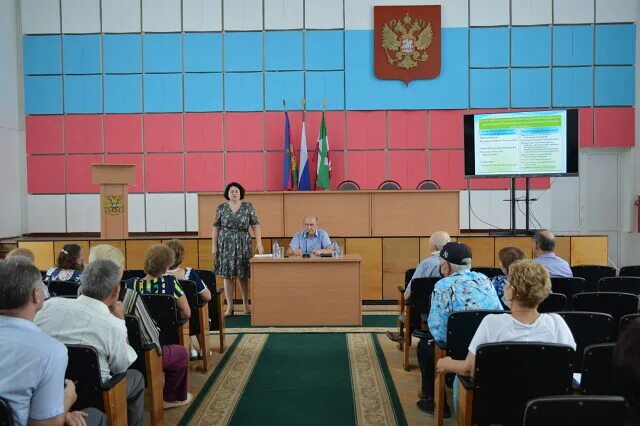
top-left (0, 256), bottom-right (107, 425)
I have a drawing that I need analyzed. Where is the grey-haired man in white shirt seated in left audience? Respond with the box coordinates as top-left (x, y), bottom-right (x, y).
top-left (36, 259), bottom-right (144, 426)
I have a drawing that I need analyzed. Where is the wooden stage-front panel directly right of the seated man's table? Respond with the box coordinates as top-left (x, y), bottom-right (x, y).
top-left (344, 238), bottom-right (382, 300)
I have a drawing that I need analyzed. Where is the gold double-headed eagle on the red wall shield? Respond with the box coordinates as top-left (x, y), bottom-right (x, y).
top-left (381, 13), bottom-right (433, 70)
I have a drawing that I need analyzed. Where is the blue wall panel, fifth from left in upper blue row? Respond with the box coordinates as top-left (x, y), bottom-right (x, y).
top-left (184, 33), bottom-right (222, 72)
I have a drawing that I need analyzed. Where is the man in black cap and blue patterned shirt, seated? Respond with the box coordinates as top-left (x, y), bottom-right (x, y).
top-left (417, 243), bottom-right (502, 417)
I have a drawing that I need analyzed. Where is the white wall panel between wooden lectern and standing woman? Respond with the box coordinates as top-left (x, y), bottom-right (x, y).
top-left (146, 194), bottom-right (186, 232)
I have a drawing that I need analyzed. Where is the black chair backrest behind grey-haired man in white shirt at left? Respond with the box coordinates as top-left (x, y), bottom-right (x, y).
top-left (65, 345), bottom-right (104, 411)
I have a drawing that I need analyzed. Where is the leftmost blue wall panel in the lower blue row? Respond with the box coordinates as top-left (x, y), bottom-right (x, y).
top-left (24, 75), bottom-right (62, 114)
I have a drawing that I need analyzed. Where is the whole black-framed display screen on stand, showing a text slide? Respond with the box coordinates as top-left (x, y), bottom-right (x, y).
top-left (464, 110), bottom-right (578, 177)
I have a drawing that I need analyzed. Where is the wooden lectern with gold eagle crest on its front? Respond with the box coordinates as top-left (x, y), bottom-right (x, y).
top-left (91, 164), bottom-right (136, 240)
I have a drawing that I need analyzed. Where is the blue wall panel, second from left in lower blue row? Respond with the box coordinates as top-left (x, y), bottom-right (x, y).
top-left (64, 75), bottom-right (102, 114)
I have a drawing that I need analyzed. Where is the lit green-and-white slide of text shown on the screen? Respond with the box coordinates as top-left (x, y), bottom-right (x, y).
top-left (474, 110), bottom-right (567, 176)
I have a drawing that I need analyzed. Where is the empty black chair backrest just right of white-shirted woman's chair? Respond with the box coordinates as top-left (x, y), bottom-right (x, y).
top-left (580, 343), bottom-right (622, 396)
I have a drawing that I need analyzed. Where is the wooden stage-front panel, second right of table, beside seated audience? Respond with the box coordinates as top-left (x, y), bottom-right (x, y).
top-left (382, 238), bottom-right (420, 300)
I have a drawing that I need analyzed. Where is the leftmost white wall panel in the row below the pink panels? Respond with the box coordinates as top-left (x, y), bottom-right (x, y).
top-left (27, 195), bottom-right (67, 233)
